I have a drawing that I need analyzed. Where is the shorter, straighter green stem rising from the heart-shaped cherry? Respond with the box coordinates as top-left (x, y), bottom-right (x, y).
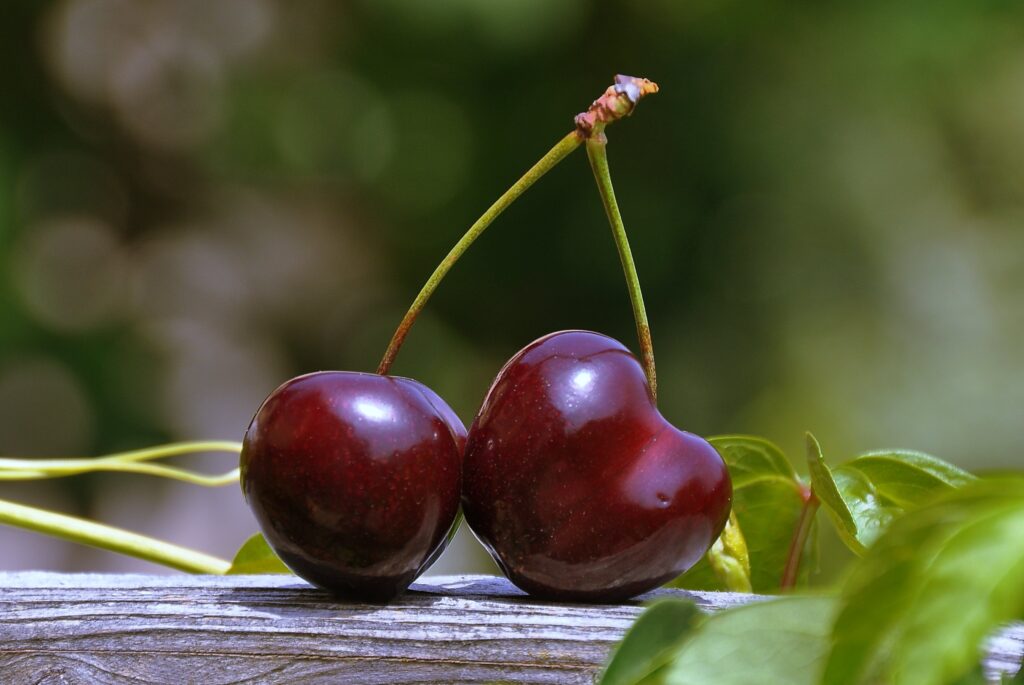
top-left (587, 129), bottom-right (657, 402)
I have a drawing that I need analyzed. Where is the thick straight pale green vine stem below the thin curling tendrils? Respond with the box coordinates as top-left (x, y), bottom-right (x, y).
top-left (0, 500), bottom-right (230, 575)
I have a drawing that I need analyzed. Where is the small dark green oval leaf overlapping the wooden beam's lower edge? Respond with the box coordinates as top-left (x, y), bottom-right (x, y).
top-left (601, 599), bottom-right (703, 685)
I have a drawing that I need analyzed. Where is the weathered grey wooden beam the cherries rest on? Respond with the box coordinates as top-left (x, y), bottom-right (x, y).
top-left (0, 572), bottom-right (1024, 685)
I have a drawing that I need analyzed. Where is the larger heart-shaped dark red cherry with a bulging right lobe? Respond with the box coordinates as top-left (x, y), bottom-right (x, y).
top-left (462, 331), bottom-right (732, 602)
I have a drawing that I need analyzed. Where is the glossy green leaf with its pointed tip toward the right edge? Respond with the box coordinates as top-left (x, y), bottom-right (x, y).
top-left (831, 451), bottom-right (976, 554)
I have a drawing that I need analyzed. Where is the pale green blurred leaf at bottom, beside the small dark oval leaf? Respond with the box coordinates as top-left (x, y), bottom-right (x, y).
top-left (645, 595), bottom-right (837, 685)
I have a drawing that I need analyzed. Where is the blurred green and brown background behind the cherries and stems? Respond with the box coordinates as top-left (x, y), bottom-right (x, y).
top-left (0, 0), bottom-right (1024, 572)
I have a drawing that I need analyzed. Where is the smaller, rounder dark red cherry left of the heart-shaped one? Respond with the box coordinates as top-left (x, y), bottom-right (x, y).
top-left (241, 372), bottom-right (466, 601)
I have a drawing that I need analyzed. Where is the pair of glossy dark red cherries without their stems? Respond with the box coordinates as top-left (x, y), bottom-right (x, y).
top-left (241, 331), bottom-right (732, 602)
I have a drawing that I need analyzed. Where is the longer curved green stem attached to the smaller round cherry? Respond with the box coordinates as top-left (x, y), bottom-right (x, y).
top-left (377, 131), bottom-right (584, 376)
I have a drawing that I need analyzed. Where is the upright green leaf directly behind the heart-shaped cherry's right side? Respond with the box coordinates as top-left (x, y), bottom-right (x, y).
top-left (673, 435), bottom-right (814, 592)
